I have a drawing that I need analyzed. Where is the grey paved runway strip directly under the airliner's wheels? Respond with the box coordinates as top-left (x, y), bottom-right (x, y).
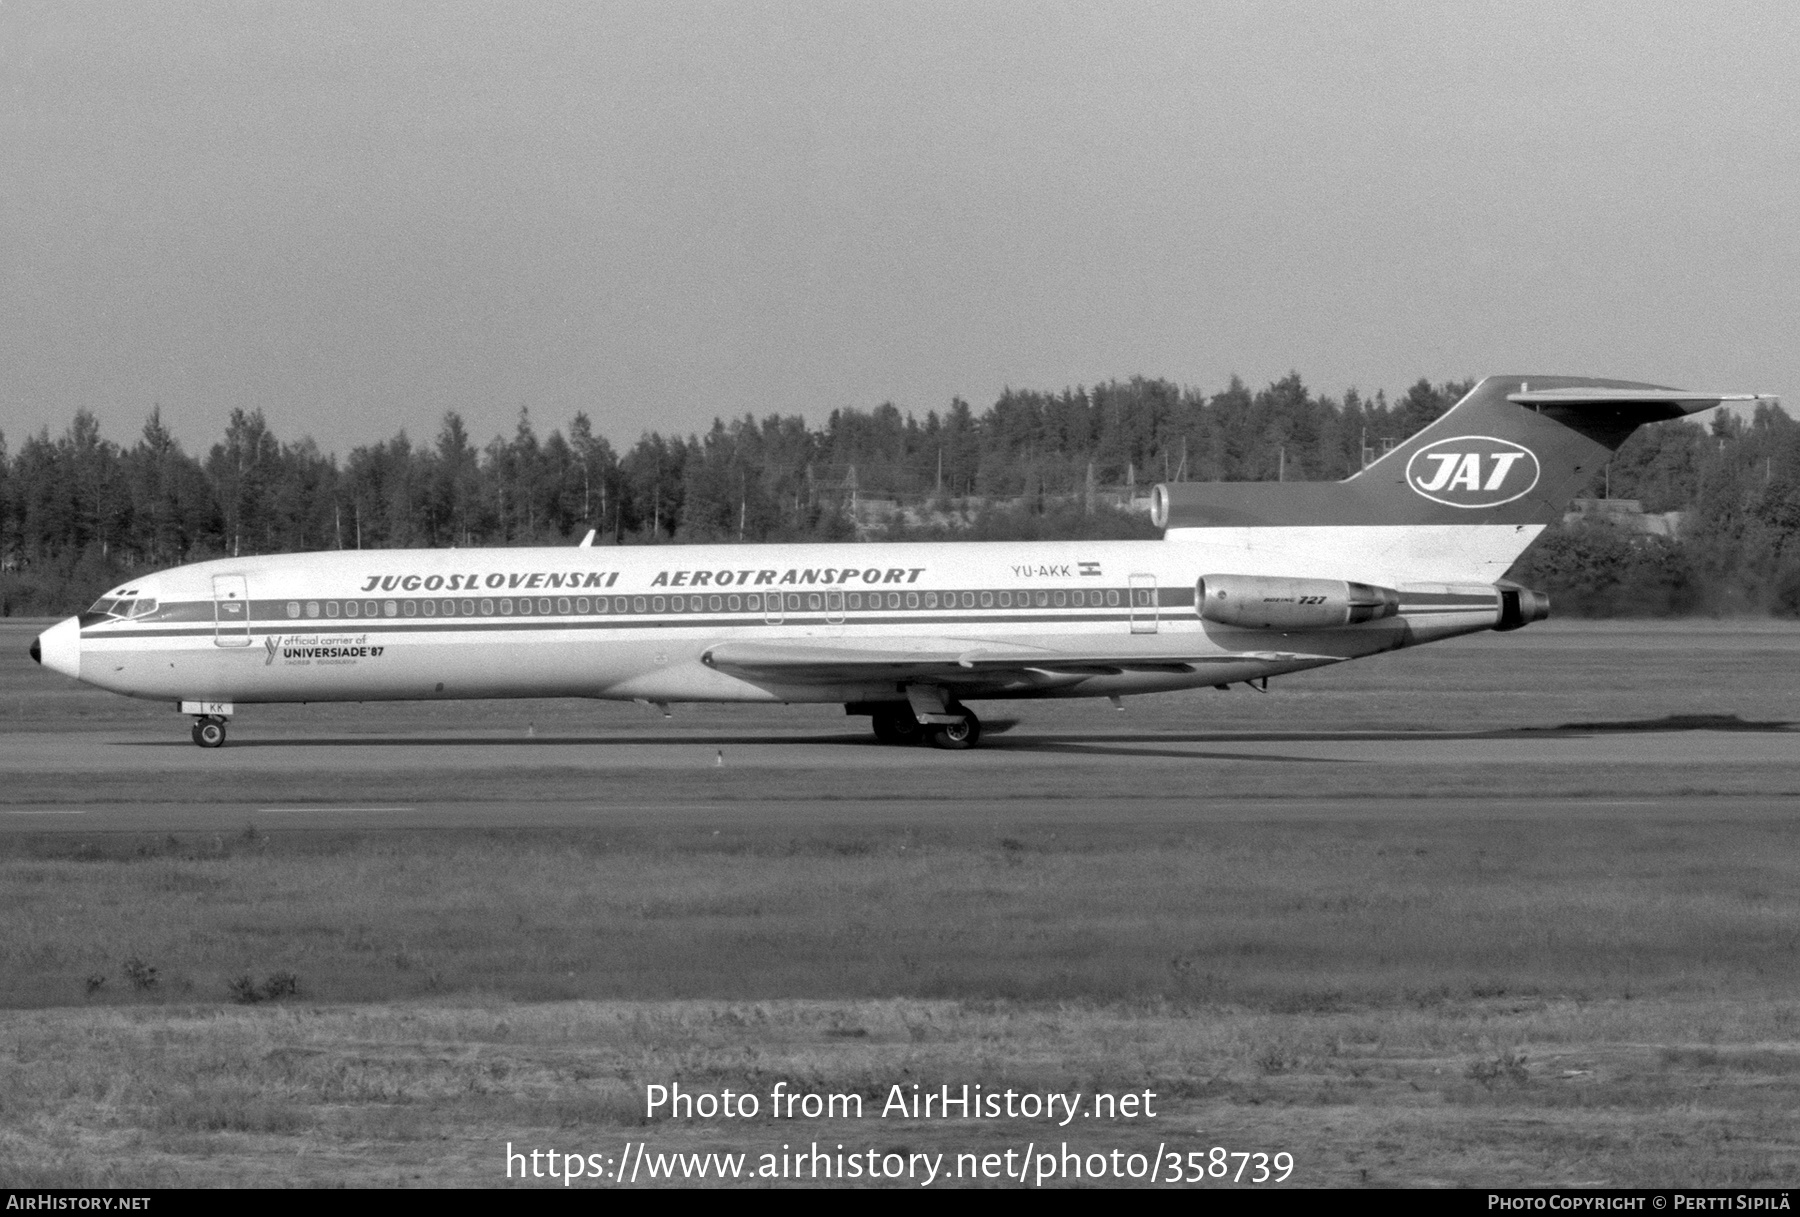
top-left (0, 718), bottom-right (1800, 832)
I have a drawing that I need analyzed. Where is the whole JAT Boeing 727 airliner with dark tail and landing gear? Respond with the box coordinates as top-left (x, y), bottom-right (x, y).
top-left (31, 376), bottom-right (1771, 749)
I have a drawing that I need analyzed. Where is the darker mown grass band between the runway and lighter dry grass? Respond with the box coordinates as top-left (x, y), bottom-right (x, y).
top-left (10, 816), bottom-right (1800, 1010)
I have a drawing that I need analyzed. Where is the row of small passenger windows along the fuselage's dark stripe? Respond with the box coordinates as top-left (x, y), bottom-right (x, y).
top-left (277, 589), bottom-right (1120, 619)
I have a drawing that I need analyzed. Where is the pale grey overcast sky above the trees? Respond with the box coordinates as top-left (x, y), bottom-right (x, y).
top-left (0, 0), bottom-right (1800, 455)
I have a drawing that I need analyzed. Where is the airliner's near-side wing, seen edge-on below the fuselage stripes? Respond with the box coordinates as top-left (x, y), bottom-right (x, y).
top-left (700, 639), bottom-right (1341, 684)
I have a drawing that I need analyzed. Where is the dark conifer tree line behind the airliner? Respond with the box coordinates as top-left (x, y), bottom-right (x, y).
top-left (0, 374), bottom-right (1800, 616)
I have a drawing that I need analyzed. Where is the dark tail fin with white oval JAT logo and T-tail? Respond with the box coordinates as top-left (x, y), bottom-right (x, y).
top-left (1152, 376), bottom-right (1775, 529)
